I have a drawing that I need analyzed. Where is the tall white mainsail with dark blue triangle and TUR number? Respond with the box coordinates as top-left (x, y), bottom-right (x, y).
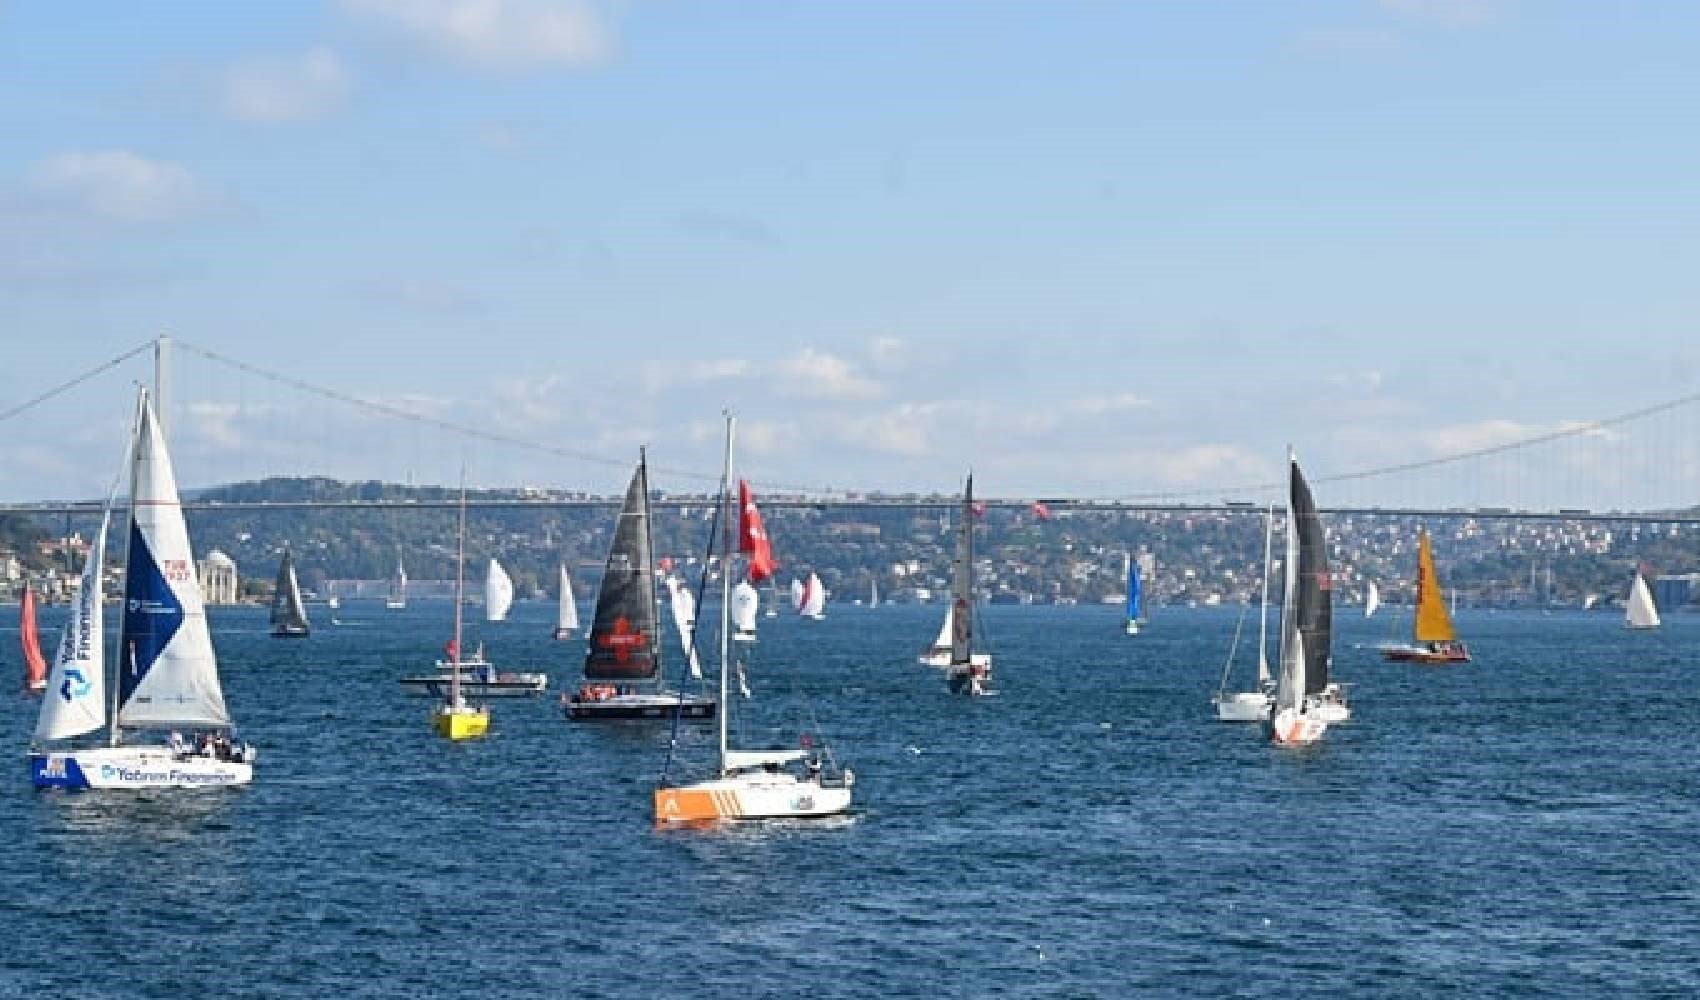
top-left (114, 393), bottom-right (231, 738)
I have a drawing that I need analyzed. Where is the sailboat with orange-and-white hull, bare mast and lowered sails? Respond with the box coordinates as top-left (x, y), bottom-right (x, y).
top-left (655, 415), bottom-right (855, 825)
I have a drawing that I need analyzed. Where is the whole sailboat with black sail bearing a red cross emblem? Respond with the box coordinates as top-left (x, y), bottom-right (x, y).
top-left (566, 456), bottom-right (716, 719)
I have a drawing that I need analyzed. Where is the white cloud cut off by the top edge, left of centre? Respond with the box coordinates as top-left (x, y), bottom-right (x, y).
top-left (342, 0), bottom-right (612, 70)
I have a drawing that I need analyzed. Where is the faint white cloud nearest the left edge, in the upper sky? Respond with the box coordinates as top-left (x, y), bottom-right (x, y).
top-left (29, 150), bottom-right (202, 223)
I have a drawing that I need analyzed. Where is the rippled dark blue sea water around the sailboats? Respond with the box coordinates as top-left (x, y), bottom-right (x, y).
top-left (0, 604), bottom-right (1700, 998)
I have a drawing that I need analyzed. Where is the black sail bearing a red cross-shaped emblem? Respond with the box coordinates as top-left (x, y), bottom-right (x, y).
top-left (585, 461), bottom-right (661, 680)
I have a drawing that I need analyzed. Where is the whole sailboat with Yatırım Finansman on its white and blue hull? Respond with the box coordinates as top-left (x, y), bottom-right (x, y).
top-left (29, 388), bottom-right (257, 789)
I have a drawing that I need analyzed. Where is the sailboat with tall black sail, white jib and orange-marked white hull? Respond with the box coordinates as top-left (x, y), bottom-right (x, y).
top-left (1270, 451), bottom-right (1333, 747)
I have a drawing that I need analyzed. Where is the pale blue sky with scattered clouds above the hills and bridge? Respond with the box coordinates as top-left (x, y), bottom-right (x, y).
top-left (0, 0), bottom-right (1700, 507)
